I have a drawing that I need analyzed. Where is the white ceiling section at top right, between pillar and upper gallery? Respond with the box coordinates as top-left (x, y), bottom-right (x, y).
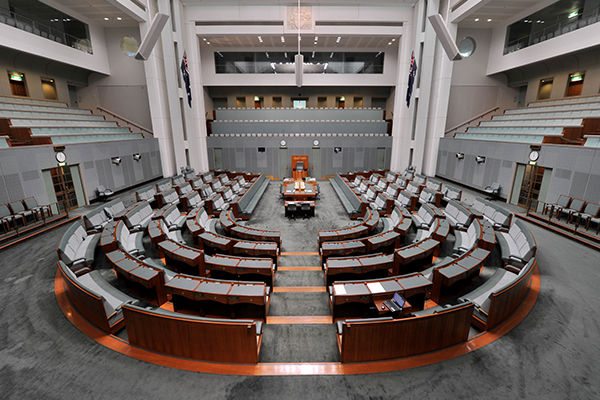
top-left (458, 0), bottom-right (547, 28)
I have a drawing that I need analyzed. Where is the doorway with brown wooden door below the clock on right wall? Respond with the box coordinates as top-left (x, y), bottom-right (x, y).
top-left (510, 164), bottom-right (552, 211)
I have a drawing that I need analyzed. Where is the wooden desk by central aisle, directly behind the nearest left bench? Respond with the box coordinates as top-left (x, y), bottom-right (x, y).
top-left (165, 275), bottom-right (269, 321)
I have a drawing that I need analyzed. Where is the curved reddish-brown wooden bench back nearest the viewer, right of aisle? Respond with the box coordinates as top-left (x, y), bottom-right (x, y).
top-left (338, 302), bottom-right (474, 363)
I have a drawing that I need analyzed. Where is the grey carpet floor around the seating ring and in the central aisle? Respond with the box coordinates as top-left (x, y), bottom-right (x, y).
top-left (0, 182), bottom-right (600, 400)
